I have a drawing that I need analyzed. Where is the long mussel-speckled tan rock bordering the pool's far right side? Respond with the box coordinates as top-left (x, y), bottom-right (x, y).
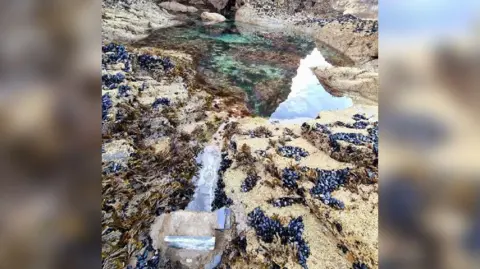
top-left (235, 0), bottom-right (378, 65)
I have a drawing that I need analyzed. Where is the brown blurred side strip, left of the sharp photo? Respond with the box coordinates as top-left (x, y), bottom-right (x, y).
top-left (0, 0), bottom-right (101, 268)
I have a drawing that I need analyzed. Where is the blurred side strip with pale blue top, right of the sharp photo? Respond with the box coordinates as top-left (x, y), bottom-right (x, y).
top-left (379, 0), bottom-right (480, 269)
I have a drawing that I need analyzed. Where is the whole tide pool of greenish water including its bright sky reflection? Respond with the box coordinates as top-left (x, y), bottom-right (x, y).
top-left (137, 22), bottom-right (352, 120)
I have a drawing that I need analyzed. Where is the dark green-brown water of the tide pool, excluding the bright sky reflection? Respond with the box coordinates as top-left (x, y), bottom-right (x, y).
top-left (135, 22), bottom-right (352, 117)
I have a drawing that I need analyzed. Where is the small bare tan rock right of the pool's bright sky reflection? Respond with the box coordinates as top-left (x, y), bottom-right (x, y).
top-left (314, 67), bottom-right (380, 105)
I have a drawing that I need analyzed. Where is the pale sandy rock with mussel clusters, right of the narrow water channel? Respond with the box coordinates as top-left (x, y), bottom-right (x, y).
top-left (218, 106), bottom-right (378, 269)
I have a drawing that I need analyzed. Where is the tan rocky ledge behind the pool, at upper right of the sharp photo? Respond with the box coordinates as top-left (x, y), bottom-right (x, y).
top-left (235, 1), bottom-right (378, 66)
